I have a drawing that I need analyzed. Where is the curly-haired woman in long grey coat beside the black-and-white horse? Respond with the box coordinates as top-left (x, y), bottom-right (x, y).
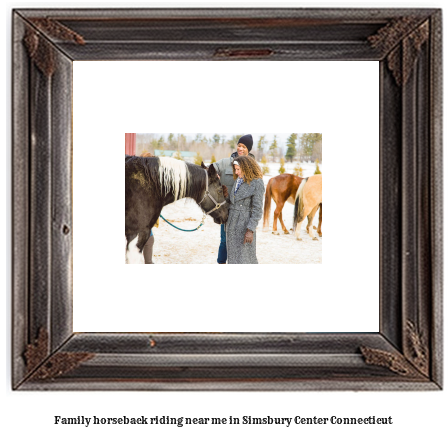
top-left (226, 156), bottom-right (265, 264)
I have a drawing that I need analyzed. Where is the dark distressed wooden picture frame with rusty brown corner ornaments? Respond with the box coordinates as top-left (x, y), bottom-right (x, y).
top-left (12, 9), bottom-right (443, 390)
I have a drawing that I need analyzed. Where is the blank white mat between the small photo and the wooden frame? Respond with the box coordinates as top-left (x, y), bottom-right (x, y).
top-left (73, 61), bottom-right (379, 332)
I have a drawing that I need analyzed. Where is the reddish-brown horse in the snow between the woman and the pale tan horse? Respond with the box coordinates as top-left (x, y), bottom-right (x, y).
top-left (263, 173), bottom-right (322, 237)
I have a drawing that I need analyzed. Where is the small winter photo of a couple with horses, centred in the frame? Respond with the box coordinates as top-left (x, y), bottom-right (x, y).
top-left (124, 132), bottom-right (324, 264)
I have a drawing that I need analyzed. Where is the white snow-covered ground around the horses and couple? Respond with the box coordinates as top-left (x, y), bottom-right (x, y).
top-left (126, 163), bottom-right (324, 264)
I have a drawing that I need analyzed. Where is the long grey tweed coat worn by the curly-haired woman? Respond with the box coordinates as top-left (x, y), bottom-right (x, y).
top-left (226, 178), bottom-right (265, 264)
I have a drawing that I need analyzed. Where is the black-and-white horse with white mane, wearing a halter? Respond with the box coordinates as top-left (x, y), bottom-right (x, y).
top-left (125, 155), bottom-right (228, 253)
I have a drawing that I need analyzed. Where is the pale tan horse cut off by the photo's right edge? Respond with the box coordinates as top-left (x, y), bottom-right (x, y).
top-left (293, 174), bottom-right (322, 240)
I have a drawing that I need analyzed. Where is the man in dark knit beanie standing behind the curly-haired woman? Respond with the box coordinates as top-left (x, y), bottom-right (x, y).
top-left (213, 134), bottom-right (255, 265)
